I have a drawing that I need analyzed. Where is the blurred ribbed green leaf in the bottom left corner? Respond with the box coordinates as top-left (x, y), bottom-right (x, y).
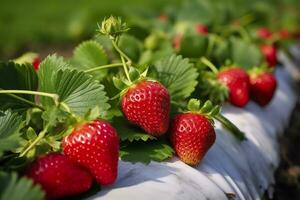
top-left (0, 172), bottom-right (45, 200)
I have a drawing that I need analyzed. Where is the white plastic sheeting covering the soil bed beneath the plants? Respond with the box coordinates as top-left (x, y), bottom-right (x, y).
top-left (90, 68), bottom-right (296, 200)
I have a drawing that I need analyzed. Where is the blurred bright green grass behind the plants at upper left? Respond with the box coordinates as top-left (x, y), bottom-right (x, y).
top-left (0, 0), bottom-right (180, 59)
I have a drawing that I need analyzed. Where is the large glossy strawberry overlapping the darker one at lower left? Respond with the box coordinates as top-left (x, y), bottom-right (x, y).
top-left (62, 120), bottom-right (119, 185)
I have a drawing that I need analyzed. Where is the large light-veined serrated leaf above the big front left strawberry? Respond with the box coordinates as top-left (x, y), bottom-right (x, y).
top-left (41, 69), bottom-right (110, 117)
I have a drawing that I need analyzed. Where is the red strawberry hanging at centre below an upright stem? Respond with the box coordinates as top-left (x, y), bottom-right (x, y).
top-left (122, 80), bottom-right (170, 136)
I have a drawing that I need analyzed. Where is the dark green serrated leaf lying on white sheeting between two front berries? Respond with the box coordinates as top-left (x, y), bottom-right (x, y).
top-left (120, 139), bottom-right (174, 164)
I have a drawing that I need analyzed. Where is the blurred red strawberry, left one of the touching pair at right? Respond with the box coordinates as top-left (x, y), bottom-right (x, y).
top-left (218, 67), bottom-right (249, 107)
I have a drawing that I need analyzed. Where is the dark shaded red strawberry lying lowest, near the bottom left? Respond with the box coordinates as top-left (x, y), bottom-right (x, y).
top-left (25, 153), bottom-right (93, 199)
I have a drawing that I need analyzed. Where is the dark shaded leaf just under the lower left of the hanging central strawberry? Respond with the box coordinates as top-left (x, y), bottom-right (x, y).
top-left (112, 117), bottom-right (156, 142)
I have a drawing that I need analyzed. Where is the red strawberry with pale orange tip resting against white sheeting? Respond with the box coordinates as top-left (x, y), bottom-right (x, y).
top-left (171, 113), bottom-right (216, 165)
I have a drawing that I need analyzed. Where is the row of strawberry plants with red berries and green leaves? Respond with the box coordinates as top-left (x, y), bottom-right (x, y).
top-left (0, 0), bottom-right (298, 199)
